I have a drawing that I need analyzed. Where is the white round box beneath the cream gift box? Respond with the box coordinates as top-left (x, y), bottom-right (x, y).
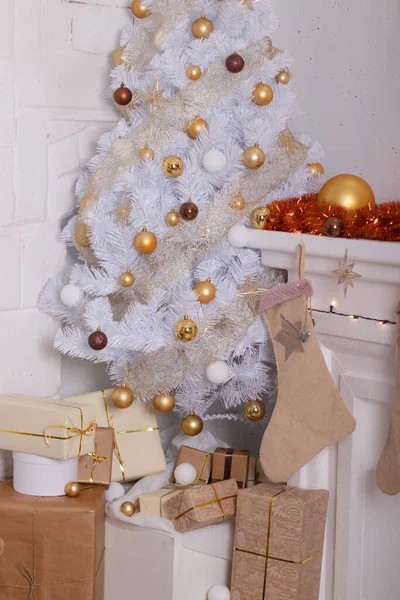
top-left (13, 452), bottom-right (79, 496)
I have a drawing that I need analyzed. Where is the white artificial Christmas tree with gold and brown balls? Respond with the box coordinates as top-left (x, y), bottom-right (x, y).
top-left (40, 0), bottom-right (322, 432)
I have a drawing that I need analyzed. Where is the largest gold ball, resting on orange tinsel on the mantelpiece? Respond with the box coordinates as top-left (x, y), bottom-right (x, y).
top-left (318, 175), bottom-right (375, 210)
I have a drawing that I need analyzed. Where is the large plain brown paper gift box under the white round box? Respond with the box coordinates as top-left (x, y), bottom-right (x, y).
top-left (0, 482), bottom-right (105, 600)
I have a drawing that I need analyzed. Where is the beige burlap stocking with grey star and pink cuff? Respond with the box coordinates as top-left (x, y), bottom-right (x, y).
top-left (260, 279), bottom-right (356, 482)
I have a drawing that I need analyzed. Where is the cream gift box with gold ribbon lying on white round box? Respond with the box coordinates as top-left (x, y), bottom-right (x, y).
top-left (0, 394), bottom-right (96, 460)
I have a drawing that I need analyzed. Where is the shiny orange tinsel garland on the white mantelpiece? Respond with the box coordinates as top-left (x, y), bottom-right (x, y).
top-left (264, 194), bottom-right (400, 242)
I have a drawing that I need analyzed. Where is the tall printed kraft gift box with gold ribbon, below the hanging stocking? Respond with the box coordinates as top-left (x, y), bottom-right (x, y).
top-left (231, 483), bottom-right (329, 600)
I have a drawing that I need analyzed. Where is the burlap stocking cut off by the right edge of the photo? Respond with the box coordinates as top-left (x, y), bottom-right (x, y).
top-left (376, 304), bottom-right (400, 496)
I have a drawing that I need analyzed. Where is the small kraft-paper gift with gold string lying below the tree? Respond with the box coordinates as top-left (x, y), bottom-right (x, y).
top-left (166, 479), bottom-right (238, 533)
